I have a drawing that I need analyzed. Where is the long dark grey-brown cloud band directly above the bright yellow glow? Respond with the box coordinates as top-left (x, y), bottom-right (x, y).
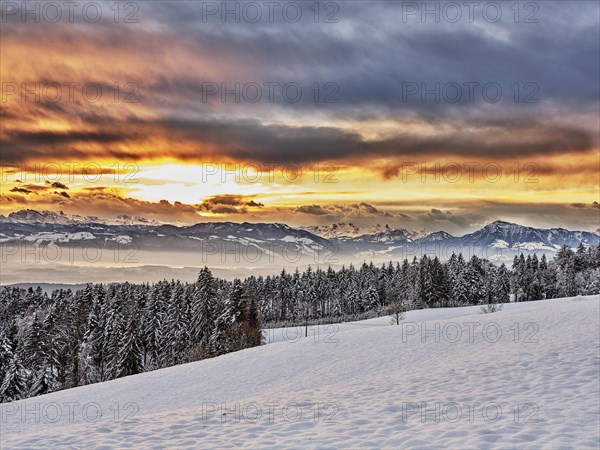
top-left (3, 114), bottom-right (594, 167)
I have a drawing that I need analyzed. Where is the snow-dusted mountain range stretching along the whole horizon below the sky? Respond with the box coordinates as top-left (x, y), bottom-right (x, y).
top-left (0, 210), bottom-right (600, 265)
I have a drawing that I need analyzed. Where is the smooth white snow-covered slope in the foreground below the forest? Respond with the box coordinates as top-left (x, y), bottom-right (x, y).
top-left (0, 296), bottom-right (600, 449)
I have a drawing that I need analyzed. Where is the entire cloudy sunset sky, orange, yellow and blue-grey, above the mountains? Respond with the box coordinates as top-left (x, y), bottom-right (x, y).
top-left (0, 1), bottom-right (600, 233)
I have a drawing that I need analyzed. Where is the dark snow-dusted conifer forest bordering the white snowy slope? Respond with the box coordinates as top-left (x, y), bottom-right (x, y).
top-left (0, 246), bottom-right (600, 402)
